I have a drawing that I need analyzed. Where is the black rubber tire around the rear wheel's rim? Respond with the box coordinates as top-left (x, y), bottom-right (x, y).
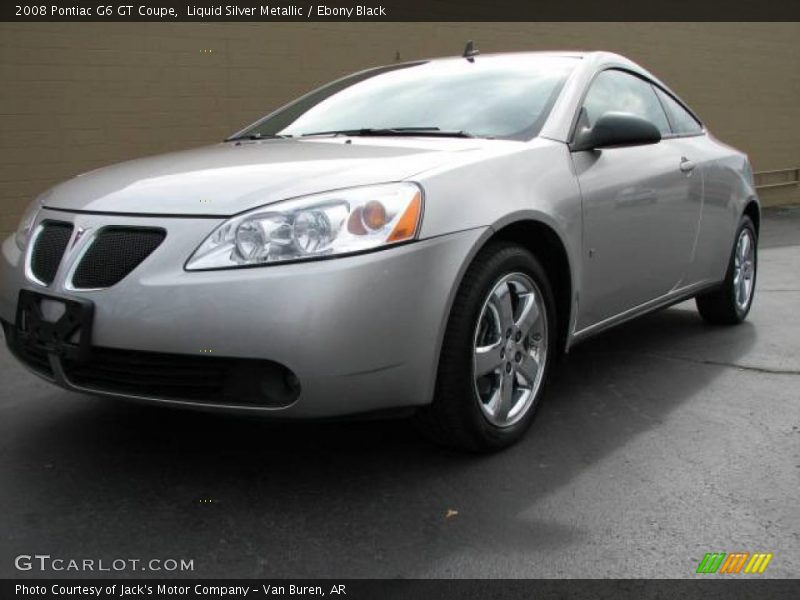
top-left (695, 215), bottom-right (758, 325)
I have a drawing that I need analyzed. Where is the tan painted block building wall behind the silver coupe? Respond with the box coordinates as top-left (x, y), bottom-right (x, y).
top-left (0, 23), bottom-right (800, 233)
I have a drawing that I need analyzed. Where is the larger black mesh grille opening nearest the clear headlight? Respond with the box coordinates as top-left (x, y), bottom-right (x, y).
top-left (72, 227), bottom-right (167, 289)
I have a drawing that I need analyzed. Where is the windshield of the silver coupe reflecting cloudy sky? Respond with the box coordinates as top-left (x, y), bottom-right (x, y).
top-left (236, 55), bottom-right (578, 140)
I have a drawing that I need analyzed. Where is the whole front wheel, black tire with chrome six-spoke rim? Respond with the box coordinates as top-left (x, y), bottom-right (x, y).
top-left (418, 242), bottom-right (556, 451)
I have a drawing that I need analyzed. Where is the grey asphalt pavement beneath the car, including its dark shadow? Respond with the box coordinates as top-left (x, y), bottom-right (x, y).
top-left (0, 209), bottom-right (800, 578)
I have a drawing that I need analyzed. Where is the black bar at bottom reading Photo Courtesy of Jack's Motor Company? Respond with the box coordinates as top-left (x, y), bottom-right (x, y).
top-left (0, 575), bottom-right (800, 600)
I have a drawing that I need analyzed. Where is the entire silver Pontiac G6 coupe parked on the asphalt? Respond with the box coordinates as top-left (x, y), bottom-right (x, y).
top-left (0, 52), bottom-right (759, 450)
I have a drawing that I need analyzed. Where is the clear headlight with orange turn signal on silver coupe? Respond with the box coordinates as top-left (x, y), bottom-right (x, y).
top-left (186, 183), bottom-right (422, 270)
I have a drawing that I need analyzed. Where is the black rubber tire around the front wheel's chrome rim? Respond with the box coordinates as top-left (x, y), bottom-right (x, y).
top-left (416, 242), bottom-right (558, 452)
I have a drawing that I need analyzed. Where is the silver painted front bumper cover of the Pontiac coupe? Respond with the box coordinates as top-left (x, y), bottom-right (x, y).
top-left (0, 210), bottom-right (485, 418)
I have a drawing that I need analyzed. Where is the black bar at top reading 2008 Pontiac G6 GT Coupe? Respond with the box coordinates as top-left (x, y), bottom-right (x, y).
top-left (0, 0), bottom-right (800, 23)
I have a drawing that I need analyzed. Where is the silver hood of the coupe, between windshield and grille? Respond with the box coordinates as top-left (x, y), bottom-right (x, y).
top-left (41, 137), bottom-right (500, 216)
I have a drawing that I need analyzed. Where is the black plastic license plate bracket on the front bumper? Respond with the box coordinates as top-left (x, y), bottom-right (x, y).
top-left (14, 290), bottom-right (94, 362)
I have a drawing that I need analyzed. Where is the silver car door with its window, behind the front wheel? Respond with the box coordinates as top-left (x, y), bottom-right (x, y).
top-left (571, 69), bottom-right (702, 330)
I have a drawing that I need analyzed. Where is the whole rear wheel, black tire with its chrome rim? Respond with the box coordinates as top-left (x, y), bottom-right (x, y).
top-left (696, 216), bottom-right (758, 325)
